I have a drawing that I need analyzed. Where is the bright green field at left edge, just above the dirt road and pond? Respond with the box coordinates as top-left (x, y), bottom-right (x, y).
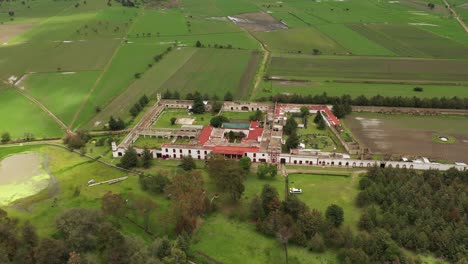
top-left (0, 86), bottom-right (63, 139)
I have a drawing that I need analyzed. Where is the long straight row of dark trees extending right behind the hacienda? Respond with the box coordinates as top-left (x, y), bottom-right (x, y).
top-left (259, 93), bottom-right (468, 109)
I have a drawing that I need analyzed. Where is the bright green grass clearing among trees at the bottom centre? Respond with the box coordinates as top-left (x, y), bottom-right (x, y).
top-left (191, 214), bottom-right (338, 264)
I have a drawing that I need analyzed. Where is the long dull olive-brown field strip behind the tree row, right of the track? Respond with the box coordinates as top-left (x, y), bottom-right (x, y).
top-left (268, 56), bottom-right (468, 84)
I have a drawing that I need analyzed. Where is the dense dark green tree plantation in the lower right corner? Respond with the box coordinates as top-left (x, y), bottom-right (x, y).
top-left (357, 167), bottom-right (468, 263)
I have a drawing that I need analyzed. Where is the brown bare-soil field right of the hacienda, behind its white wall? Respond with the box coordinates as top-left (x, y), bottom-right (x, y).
top-left (344, 113), bottom-right (468, 162)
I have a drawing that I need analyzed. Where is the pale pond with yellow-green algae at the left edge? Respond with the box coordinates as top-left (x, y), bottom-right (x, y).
top-left (0, 153), bottom-right (51, 206)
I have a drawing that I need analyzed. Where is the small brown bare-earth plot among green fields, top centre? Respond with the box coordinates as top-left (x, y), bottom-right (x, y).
top-left (228, 13), bottom-right (288, 32)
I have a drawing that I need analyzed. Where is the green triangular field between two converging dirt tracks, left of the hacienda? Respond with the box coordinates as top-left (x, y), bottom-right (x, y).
top-left (19, 71), bottom-right (101, 124)
